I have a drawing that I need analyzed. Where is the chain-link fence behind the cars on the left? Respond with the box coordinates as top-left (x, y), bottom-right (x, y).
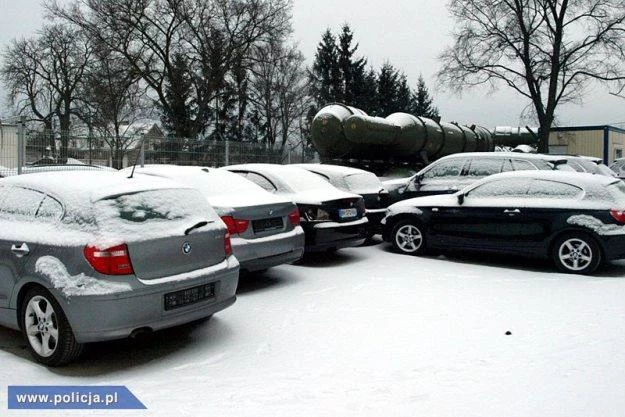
top-left (0, 123), bottom-right (316, 176)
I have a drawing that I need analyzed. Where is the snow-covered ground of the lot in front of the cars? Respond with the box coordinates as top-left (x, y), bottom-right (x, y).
top-left (0, 239), bottom-right (625, 417)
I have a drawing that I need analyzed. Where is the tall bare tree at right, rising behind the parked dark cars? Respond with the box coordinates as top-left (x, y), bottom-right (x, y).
top-left (438, 0), bottom-right (625, 153)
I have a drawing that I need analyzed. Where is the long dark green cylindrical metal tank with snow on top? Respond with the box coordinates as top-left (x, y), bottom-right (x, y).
top-left (312, 104), bottom-right (536, 162)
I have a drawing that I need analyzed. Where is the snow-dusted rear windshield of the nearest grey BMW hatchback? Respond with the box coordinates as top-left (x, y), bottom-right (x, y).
top-left (94, 189), bottom-right (217, 239)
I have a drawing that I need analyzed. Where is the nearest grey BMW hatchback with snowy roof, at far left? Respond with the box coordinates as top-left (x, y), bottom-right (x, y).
top-left (0, 171), bottom-right (239, 366)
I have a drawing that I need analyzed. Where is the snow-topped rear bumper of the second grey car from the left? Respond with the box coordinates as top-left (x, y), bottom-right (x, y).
top-left (232, 227), bottom-right (304, 271)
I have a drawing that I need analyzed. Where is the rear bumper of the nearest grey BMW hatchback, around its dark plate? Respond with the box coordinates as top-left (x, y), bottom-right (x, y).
top-left (53, 256), bottom-right (239, 343)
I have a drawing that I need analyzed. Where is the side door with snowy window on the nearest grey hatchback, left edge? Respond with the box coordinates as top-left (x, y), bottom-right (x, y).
top-left (0, 186), bottom-right (45, 308)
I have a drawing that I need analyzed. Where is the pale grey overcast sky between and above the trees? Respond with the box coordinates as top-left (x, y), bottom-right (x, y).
top-left (0, 0), bottom-right (625, 127)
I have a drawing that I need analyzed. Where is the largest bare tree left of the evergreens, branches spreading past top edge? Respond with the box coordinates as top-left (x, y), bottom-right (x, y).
top-left (46, 0), bottom-right (291, 137)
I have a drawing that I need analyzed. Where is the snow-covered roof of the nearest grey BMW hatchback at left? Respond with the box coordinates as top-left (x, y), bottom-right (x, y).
top-left (0, 171), bottom-right (190, 201)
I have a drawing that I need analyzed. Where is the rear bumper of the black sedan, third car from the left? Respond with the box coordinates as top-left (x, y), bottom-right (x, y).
top-left (302, 218), bottom-right (369, 252)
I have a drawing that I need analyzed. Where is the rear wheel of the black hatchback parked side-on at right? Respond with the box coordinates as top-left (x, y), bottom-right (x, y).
top-left (552, 232), bottom-right (601, 274)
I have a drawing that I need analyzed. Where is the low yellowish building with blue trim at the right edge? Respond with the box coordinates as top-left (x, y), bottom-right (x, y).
top-left (549, 125), bottom-right (625, 165)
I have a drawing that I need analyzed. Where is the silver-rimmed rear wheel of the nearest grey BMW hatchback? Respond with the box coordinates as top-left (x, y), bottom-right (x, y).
top-left (20, 287), bottom-right (83, 366)
